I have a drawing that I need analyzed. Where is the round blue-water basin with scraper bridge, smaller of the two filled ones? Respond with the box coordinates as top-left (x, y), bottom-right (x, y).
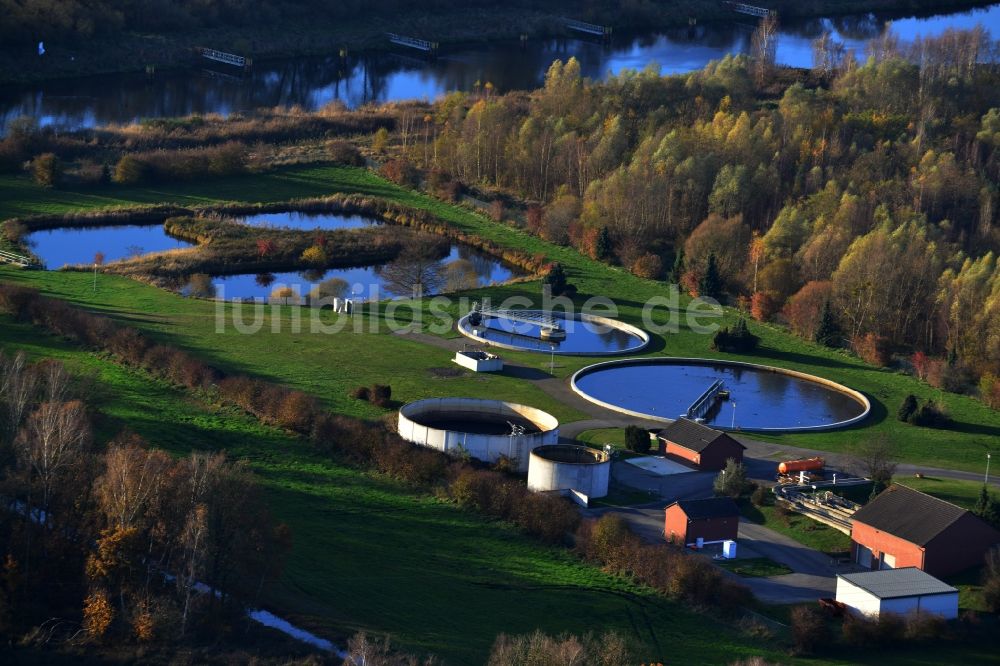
top-left (459, 310), bottom-right (648, 355)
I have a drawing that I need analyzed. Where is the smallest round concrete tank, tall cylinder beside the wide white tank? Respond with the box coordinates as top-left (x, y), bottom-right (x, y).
top-left (528, 444), bottom-right (611, 499)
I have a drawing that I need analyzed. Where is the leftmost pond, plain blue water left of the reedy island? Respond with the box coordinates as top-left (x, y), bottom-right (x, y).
top-left (26, 224), bottom-right (191, 269)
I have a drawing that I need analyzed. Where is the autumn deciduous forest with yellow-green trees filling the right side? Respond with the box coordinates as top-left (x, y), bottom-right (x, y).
top-left (390, 27), bottom-right (1000, 405)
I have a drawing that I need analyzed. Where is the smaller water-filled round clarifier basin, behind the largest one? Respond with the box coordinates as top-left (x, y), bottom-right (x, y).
top-left (458, 310), bottom-right (649, 356)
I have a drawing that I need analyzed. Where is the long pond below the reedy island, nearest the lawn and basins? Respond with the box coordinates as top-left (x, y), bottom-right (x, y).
top-left (205, 244), bottom-right (525, 301)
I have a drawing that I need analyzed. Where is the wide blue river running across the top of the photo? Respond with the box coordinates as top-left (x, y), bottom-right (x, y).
top-left (0, 4), bottom-right (1000, 131)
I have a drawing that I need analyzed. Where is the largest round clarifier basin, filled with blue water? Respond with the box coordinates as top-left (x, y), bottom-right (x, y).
top-left (572, 358), bottom-right (871, 432)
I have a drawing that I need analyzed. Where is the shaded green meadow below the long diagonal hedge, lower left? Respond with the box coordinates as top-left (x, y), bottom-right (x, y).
top-left (0, 317), bottom-right (774, 664)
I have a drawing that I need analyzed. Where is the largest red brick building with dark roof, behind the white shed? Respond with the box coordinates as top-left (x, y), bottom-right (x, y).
top-left (851, 485), bottom-right (1000, 576)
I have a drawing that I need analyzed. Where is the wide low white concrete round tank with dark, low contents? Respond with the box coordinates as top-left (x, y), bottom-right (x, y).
top-left (398, 398), bottom-right (559, 472)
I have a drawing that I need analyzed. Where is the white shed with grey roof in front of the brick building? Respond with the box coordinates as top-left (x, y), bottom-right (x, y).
top-left (837, 567), bottom-right (958, 620)
